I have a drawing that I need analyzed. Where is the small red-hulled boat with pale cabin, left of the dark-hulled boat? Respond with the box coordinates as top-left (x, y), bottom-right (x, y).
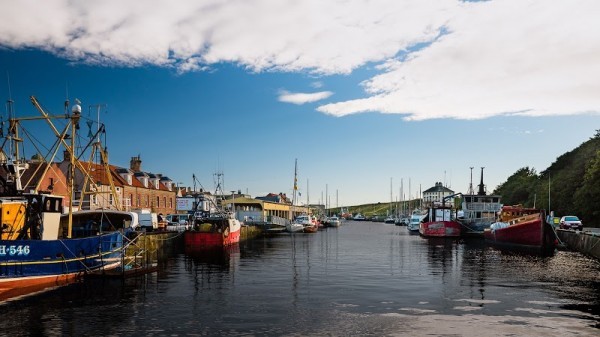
top-left (419, 205), bottom-right (461, 237)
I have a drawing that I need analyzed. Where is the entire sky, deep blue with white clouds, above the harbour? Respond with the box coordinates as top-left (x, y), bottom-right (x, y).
top-left (0, 0), bottom-right (600, 206)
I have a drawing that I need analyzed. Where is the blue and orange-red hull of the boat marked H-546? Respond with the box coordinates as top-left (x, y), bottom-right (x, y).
top-left (0, 232), bottom-right (123, 301)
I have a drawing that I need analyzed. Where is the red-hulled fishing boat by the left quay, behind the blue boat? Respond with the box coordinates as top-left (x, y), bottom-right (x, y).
top-left (184, 173), bottom-right (242, 249)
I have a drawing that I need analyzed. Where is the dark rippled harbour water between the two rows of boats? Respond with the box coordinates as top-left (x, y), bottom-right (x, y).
top-left (0, 221), bottom-right (600, 336)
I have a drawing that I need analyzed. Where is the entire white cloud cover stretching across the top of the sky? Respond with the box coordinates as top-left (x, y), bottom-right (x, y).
top-left (0, 0), bottom-right (600, 120)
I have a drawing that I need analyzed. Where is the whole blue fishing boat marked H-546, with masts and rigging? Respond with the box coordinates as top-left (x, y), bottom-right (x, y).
top-left (0, 96), bottom-right (124, 301)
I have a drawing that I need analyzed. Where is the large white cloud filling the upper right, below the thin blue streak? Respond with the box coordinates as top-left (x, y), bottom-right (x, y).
top-left (318, 0), bottom-right (600, 120)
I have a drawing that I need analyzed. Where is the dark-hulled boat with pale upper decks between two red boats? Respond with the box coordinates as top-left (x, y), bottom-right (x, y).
top-left (457, 167), bottom-right (502, 237)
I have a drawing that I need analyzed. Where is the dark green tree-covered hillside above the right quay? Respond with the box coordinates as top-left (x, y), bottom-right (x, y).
top-left (494, 130), bottom-right (600, 227)
